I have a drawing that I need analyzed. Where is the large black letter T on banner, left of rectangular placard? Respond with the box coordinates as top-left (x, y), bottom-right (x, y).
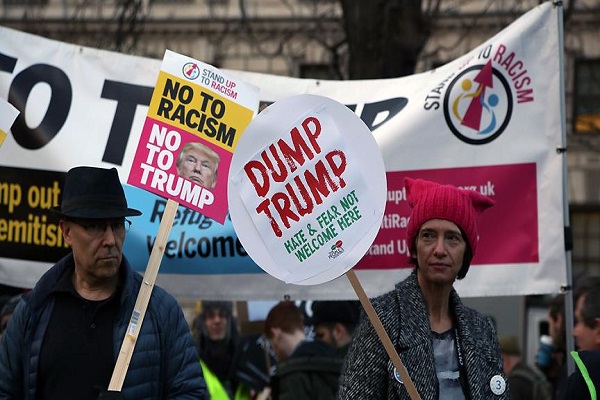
top-left (102, 80), bottom-right (154, 165)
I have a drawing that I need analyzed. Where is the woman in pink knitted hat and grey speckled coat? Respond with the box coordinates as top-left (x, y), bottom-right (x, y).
top-left (338, 178), bottom-right (510, 400)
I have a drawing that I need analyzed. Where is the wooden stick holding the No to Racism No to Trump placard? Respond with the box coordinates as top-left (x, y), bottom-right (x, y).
top-left (108, 199), bottom-right (179, 392)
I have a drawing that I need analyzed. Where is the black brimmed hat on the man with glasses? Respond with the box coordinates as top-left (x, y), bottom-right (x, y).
top-left (51, 167), bottom-right (142, 219)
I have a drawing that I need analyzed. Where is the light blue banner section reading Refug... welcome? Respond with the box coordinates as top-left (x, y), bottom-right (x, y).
top-left (123, 185), bottom-right (264, 275)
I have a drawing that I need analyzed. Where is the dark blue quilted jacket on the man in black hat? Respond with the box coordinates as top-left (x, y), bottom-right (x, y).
top-left (0, 253), bottom-right (207, 400)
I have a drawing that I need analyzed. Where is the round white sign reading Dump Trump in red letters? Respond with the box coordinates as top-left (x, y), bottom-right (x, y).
top-left (228, 94), bottom-right (387, 285)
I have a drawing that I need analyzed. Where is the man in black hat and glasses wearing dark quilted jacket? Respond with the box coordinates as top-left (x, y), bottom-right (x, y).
top-left (0, 167), bottom-right (206, 400)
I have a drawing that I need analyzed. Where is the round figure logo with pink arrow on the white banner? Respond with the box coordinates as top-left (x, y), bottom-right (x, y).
top-left (444, 61), bottom-right (513, 145)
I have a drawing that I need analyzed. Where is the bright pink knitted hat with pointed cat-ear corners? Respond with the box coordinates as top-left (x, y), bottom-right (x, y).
top-left (404, 178), bottom-right (494, 255)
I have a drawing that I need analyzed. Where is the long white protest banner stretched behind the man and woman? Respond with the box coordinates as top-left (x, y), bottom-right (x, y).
top-left (0, 2), bottom-right (566, 299)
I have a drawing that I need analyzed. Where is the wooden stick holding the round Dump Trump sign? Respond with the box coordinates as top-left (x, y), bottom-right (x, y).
top-left (346, 270), bottom-right (421, 400)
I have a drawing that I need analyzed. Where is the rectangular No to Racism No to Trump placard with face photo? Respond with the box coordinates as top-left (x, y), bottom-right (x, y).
top-left (127, 50), bottom-right (258, 223)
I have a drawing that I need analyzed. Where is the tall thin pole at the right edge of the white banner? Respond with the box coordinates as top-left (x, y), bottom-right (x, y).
top-left (552, 0), bottom-right (575, 375)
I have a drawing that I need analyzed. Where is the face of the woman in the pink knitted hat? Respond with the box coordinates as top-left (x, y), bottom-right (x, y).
top-left (416, 219), bottom-right (467, 284)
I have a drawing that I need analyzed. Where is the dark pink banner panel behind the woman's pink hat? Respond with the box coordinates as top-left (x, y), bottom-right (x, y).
top-left (355, 163), bottom-right (539, 269)
